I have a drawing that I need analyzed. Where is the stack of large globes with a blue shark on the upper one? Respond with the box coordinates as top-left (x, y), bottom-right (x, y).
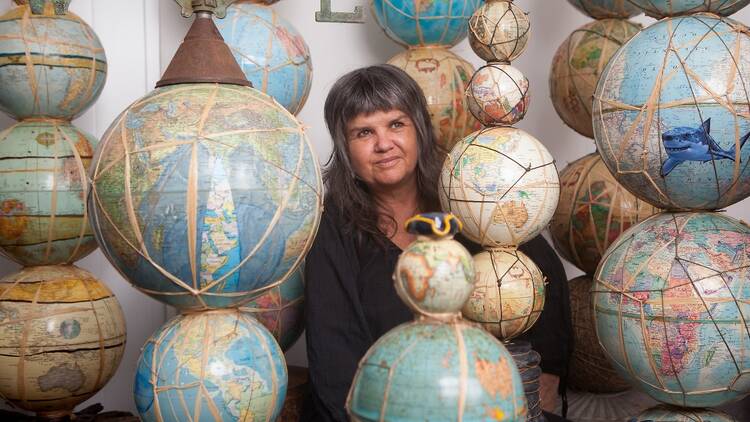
top-left (592, 0), bottom-right (750, 420)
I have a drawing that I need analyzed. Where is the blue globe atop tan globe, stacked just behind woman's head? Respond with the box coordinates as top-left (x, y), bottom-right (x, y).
top-left (371, 0), bottom-right (481, 152)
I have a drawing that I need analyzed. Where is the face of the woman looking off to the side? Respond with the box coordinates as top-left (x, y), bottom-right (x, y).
top-left (346, 110), bottom-right (419, 192)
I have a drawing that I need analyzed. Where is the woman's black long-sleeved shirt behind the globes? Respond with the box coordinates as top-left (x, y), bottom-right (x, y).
top-left (303, 201), bottom-right (572, 422)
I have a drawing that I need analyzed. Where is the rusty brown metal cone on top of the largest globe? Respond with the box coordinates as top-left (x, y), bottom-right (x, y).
top-left (156, 13), bottom-right (252, 88)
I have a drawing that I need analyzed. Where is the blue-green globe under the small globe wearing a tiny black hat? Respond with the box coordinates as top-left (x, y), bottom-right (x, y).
top-left (346, 320), bottom-right (528, 422)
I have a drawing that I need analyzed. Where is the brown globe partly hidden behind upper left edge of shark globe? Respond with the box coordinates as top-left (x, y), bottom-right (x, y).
top-left (549, 19), bottom-right (641, 138)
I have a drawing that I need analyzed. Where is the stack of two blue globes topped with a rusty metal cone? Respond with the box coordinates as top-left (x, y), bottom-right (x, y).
top-left (89, 0), bottom-right (322, 421)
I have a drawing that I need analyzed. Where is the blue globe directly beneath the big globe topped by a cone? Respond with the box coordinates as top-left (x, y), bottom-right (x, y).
top-left (134, 309), bottom-right (287, 422)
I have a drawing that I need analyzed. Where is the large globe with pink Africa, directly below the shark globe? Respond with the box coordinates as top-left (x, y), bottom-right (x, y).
top-left (592, 212), bottom-right (750, 407)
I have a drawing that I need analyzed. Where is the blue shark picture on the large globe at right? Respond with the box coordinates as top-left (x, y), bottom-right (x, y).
top-left (661, 118), bottom-right (750, 177)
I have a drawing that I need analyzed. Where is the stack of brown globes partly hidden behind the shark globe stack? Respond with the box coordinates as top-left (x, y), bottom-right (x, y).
top-left (549, 0), bottom-right (658, 402)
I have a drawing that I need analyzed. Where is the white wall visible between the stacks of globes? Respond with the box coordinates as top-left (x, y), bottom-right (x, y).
top-left (0, 0), bottom-right (750, 412)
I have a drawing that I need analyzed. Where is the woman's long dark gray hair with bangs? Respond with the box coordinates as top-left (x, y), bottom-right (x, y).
top-left (323, 64), bottom-right (445, 244)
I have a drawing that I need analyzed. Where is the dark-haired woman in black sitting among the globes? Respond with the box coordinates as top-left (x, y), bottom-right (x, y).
top-left (303, 65), bottom-right (570, 421)
